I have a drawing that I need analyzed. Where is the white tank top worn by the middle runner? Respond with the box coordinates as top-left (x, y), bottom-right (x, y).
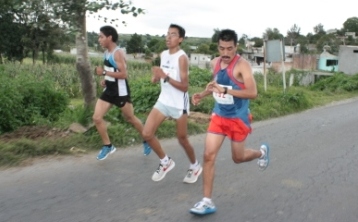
top-left (158, 49), bottom-right (190, 111)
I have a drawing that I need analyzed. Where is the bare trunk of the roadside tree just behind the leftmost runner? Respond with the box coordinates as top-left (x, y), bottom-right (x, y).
top-left (76, 12), bottom-right (96, 108)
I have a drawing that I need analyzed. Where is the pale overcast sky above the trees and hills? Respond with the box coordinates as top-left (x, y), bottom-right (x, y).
top-left (87, 0), bottom-right (358, 38)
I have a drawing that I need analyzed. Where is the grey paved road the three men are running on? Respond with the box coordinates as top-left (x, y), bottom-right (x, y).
top-left (0, 99), bottom-right (358, 222)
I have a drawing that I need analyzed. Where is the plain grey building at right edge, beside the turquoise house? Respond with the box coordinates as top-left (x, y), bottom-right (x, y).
top-left (338, 45), bottom-right (358, 75)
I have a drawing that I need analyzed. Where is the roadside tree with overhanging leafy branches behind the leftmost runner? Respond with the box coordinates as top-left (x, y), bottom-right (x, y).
top-left (47, 0), bottom-right (144, 108)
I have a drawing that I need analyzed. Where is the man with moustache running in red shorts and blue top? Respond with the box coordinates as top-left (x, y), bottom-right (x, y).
top-left (190, 29), bottom-right (270, 215)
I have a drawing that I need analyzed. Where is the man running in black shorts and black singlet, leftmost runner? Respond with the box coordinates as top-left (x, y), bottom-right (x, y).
top-left (93, 26), bottom-right (151, 160)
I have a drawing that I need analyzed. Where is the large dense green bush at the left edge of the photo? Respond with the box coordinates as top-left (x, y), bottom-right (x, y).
top-left (0, 64), bottom-right (69, 134)
